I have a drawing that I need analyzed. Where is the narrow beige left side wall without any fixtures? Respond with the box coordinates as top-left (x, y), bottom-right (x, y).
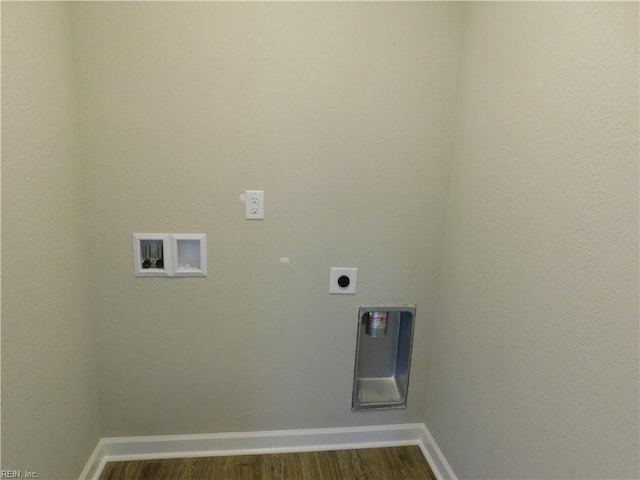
top-left (2, 2), bottom-right (100, 479)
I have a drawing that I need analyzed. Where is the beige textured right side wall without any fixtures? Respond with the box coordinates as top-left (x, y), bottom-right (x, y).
top-left (426, 2), bottom-right (640, 479)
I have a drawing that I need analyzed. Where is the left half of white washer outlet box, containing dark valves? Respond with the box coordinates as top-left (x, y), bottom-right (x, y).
top-left (133, 233), bottom-right (171, 277)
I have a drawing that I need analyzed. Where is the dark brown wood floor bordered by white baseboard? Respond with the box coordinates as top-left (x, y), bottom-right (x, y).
top-left (100, 446), bottom-right (435, 480)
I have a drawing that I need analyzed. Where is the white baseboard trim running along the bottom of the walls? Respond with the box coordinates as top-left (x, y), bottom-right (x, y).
top-left (80, 423), bottom-right (457, 480)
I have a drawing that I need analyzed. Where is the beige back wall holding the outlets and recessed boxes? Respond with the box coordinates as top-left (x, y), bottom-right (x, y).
top-left (74, 2), bottom-right (462, 435)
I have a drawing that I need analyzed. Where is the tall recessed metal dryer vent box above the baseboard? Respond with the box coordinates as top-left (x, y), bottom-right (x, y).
top-left (351, 305), bottom-right (416, 411)
